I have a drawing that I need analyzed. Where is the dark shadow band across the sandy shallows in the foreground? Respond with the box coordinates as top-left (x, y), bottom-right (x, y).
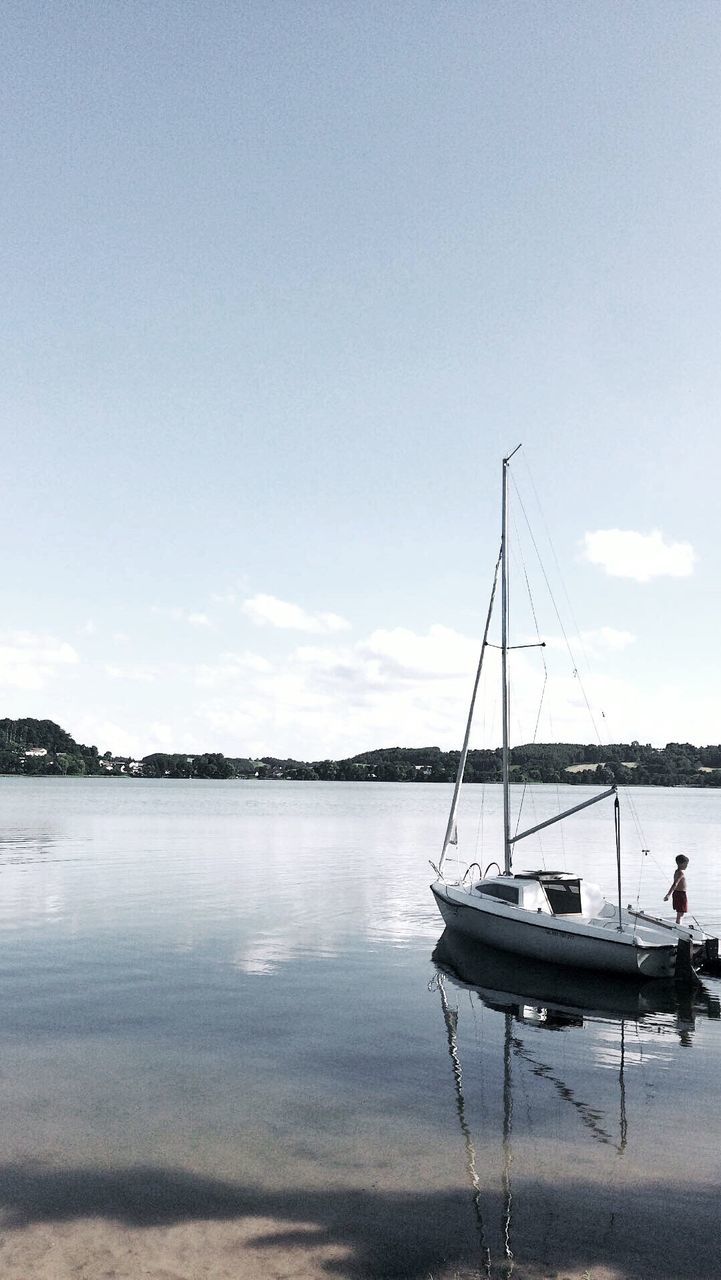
top-left (0, 1165), bottom-right (720, 1280)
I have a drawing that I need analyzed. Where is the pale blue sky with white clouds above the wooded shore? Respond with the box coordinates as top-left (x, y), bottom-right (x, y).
top-left (0, 0), bottom-right (721, 759)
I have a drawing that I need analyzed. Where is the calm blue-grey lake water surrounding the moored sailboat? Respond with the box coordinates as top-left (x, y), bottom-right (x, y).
top-left (0, 778), bottom-right (721, 1280)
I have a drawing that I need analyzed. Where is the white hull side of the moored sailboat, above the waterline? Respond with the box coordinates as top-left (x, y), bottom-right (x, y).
top-left (430, 883), bottom-right (679, 978)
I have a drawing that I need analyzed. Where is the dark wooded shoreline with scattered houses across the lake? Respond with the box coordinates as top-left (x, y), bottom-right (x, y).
top-left (0, 718), bottom-right (721, 787)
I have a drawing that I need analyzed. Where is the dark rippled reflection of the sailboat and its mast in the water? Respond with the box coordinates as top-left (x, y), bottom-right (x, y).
top-left (433, 929), bottom-right (721, 1280)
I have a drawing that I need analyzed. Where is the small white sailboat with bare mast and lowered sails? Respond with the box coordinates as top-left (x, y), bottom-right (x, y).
top-left (430, 445), bottom-right (707, 978)
